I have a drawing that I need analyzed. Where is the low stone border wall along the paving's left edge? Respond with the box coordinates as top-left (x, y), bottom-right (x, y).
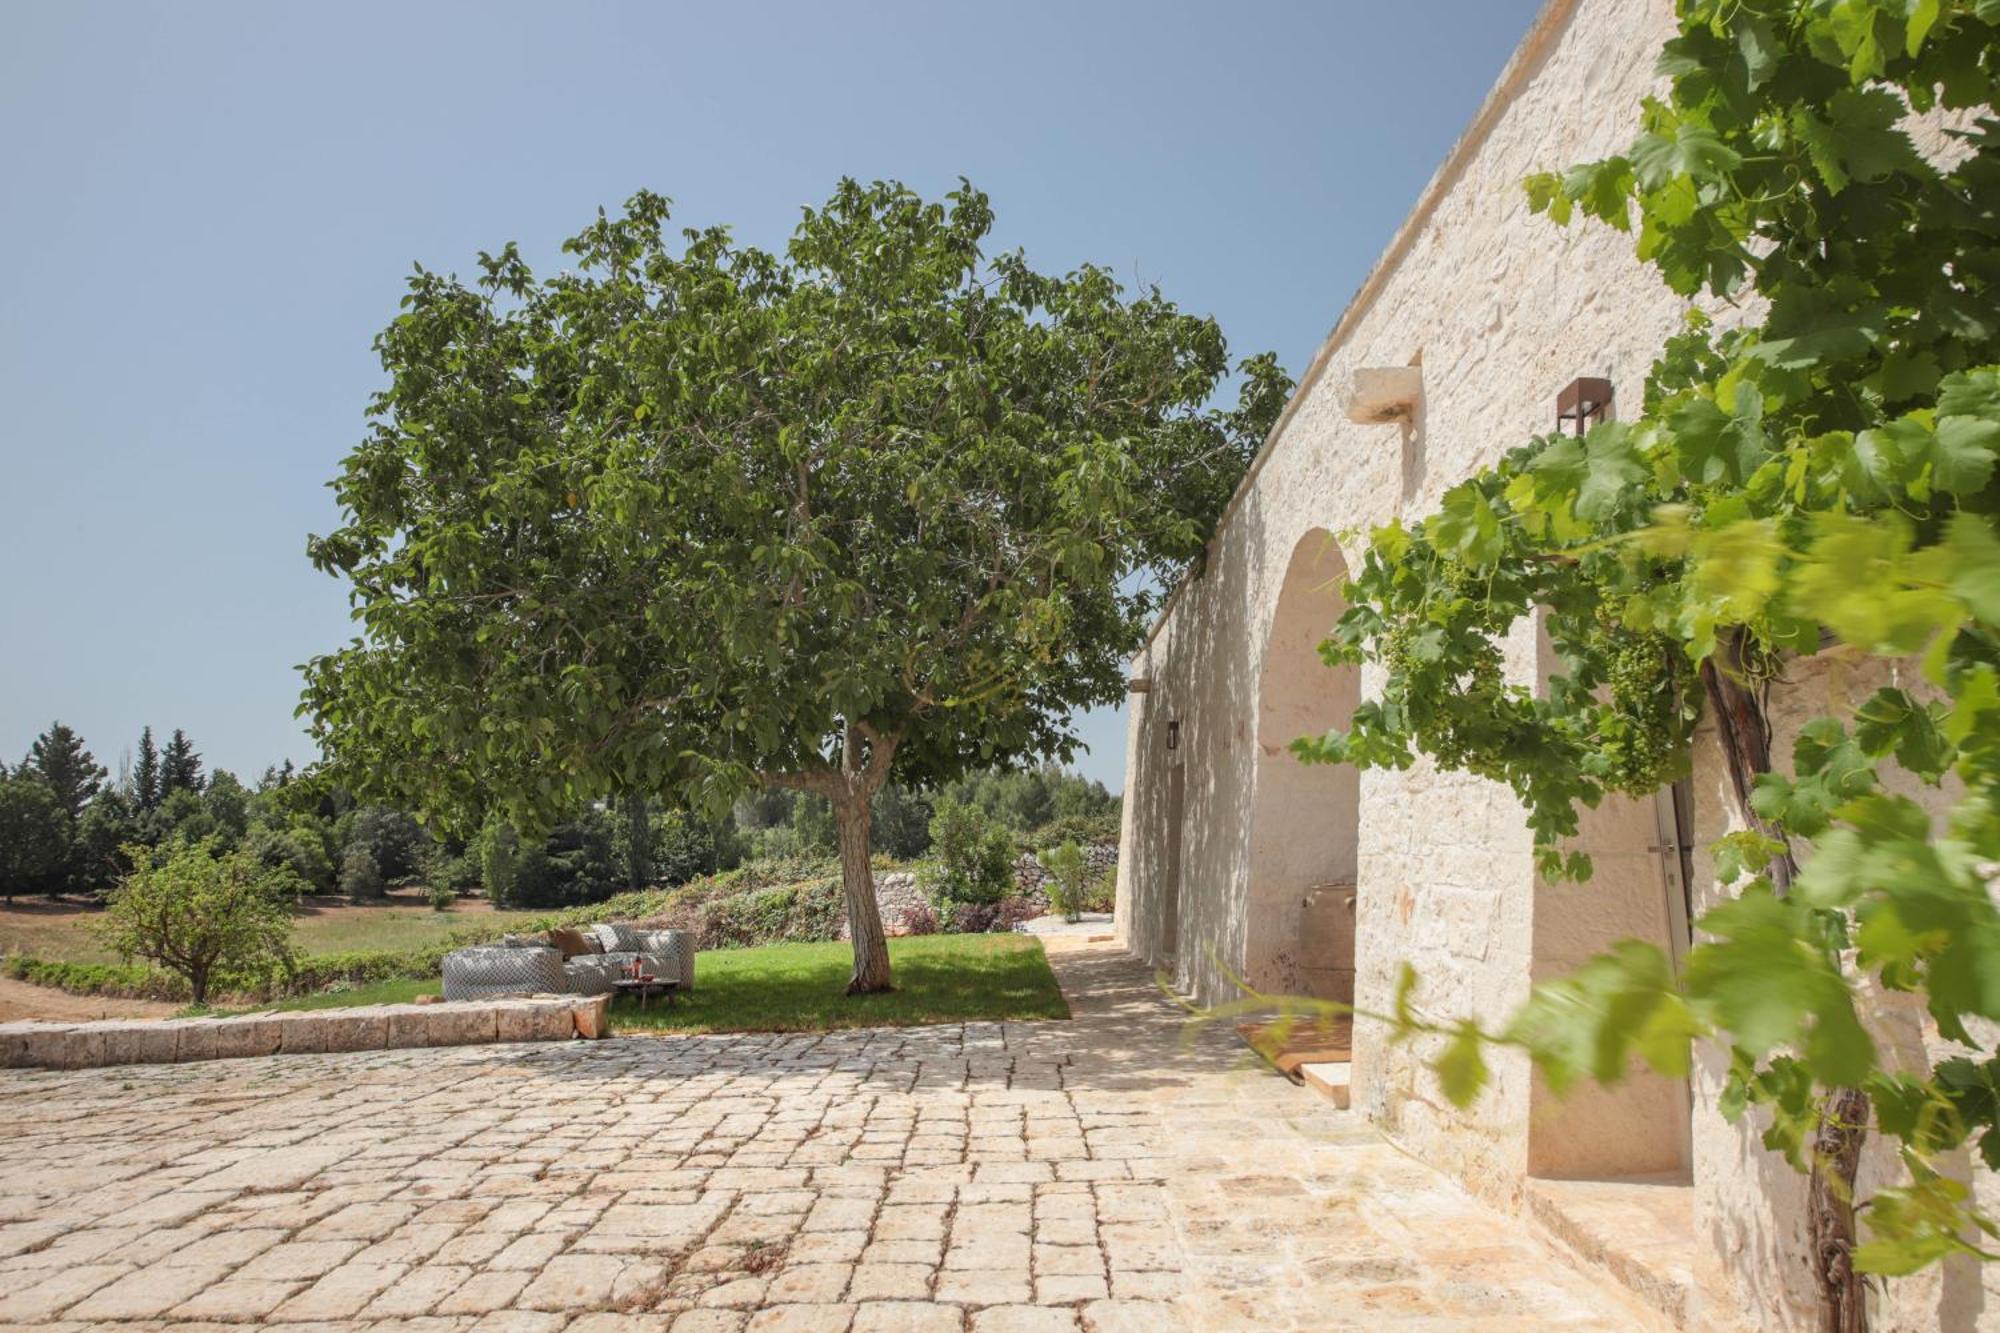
top-left (0, 995), bottom-right (610, 1069)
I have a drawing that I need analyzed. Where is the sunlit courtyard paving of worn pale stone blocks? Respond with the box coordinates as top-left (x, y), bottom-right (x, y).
top-left (0, 947), bottom-right (1636, 1333)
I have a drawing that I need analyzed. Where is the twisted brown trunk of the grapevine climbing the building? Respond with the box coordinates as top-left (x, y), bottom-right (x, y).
top-left (1702, 630), bottom-right (1868, 1333)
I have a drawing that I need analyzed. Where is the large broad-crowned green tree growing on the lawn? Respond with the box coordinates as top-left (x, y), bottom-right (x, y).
top-left (302, 180), bottom-right (1290, 991)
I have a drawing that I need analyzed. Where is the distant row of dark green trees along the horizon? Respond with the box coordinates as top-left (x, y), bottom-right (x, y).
top-left (0, 721), bottom-right (1118, 907)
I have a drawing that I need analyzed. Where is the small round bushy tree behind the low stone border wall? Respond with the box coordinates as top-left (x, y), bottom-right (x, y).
top-left (96, 839), bottom-right (292, 1005)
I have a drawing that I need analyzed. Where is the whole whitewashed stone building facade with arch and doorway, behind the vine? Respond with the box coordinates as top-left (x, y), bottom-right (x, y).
top-left (1118, 0), bottom-right (2000, 1329)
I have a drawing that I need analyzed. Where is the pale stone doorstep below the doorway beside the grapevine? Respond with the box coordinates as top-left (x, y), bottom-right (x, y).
top-left (1526, 1177), bottom-right (1714, 1329)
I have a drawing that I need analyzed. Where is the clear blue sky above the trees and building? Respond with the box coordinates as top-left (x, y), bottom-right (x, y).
top-left (0, 0), bottom-right (1538, 789)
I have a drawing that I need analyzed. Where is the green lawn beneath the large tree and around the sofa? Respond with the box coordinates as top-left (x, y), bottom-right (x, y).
top-left (232, 935), bottom-right (1070, 1033)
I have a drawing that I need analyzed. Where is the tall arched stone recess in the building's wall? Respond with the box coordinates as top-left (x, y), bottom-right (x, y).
top-left (1244, 528), bottom-right (1360, 1003)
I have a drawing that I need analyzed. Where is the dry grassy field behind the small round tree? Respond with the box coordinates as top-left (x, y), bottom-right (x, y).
top-left (0, 889), bottom-right (548, 963)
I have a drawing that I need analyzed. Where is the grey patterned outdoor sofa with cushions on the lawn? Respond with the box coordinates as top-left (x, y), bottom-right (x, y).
top-left (444, 921), bottom-right (694, 999)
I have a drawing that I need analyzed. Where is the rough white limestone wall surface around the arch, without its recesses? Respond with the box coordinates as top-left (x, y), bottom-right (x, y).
top-left (1120, 0), bottom-right (1682, 1201)
